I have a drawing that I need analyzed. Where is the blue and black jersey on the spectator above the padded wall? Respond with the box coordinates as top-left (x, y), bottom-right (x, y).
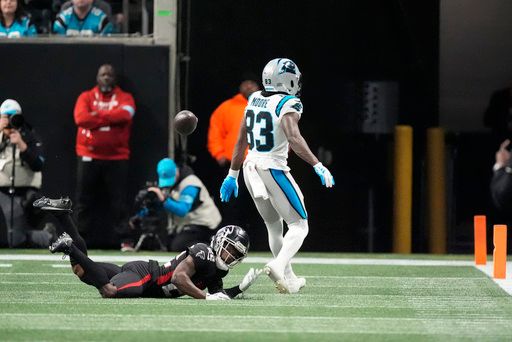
top-left (53, 6), bottom-right (113, 36)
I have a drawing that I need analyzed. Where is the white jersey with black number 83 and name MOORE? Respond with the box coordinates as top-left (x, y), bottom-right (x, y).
top-left (244, 91), bottom-right (303, 171)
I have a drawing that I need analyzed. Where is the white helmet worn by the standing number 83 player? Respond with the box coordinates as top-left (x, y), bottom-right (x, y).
top-left (261, 58), bottom-right (302, 97)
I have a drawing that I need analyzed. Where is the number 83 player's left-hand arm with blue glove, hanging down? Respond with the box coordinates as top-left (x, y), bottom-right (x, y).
top-left (220, 117), bottom-right (248, 202)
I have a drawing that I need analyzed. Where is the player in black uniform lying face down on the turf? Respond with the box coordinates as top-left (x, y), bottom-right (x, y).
top-left (34, 197), bottom-right (261, 300)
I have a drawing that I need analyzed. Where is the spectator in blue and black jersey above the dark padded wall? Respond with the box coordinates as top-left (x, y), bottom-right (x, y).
top-left (53, 0), bottom-right (113, 36)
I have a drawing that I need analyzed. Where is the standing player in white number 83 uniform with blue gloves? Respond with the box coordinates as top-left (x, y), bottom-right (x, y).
top-left (220, 58), bottom-right (334, 293)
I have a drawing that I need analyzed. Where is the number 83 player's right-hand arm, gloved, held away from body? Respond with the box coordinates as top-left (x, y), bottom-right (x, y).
top-left (281, 113), bottom-right (334, 188)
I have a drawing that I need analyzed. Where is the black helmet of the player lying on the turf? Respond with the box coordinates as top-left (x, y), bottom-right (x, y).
top-left (211, 225), bottom-right (250, 271)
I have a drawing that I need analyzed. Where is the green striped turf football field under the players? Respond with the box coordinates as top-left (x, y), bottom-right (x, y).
top-left (0, 250), bottom-right (512, 342)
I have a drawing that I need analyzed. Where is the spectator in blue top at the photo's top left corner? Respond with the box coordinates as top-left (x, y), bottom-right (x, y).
top-left (0, 0), bottom-right (37, 38)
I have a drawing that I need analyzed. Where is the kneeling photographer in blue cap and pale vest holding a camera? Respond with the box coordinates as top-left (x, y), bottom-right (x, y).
top-left (130, 158), bottom-right (222, 251)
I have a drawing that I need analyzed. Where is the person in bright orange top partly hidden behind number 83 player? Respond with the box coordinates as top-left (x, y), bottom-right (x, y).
top-left (208, 73), bottom-right (260, 227)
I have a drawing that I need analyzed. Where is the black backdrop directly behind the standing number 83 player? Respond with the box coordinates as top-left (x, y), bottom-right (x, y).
top-left (184, 0), bottom-right (439, 251)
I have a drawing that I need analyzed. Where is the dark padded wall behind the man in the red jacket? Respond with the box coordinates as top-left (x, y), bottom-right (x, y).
top-left (0, 44), bottom-right (169, 212)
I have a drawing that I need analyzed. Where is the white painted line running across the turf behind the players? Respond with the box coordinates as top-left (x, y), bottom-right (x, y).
top-left (0, 254), bottom-right (512, 295)
